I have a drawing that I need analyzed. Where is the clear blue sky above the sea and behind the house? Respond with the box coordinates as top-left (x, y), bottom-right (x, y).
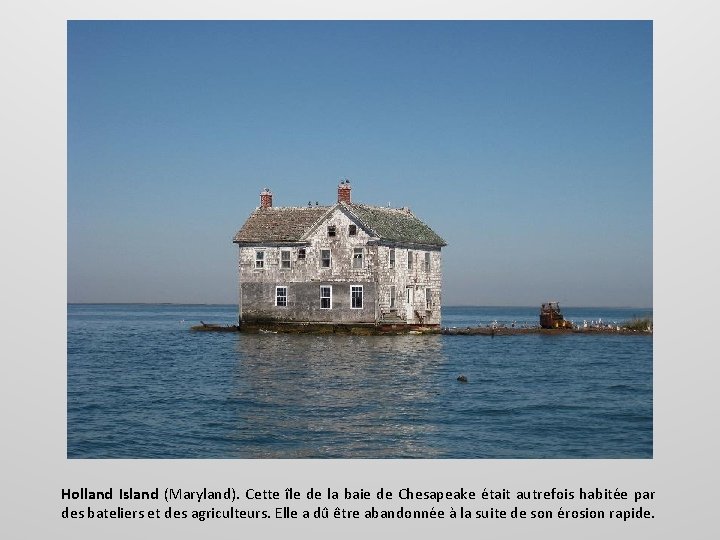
top-left (67, 21), bottom-right (653, 307)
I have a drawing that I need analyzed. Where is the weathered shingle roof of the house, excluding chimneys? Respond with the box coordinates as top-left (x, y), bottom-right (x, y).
top-left (233, 203), bottom-right (447, 247)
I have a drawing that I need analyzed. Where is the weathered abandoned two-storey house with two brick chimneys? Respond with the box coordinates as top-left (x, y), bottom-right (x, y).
top-left (233, 180), bottom-right (446, 328)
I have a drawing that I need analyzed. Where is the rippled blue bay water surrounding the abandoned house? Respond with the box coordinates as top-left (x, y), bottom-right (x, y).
top-left (67, 304), bottom-right (653, 458)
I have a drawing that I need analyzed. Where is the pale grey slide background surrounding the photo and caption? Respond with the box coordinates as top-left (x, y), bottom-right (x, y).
top-left (0, 0), bottom-right (720, 538)
